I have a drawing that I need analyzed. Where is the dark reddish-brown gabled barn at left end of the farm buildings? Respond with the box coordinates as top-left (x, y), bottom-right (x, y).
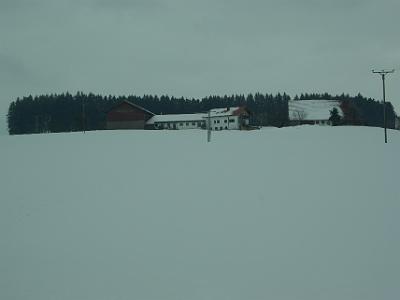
top-left (106, 100), bottom-right (154, 129)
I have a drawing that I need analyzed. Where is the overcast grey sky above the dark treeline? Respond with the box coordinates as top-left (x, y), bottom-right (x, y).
top-left (0, 0), bottom-right (400, 133)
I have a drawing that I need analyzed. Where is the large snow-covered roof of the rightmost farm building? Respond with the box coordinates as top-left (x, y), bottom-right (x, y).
top-left (289, 100), bottom-right (343, 121)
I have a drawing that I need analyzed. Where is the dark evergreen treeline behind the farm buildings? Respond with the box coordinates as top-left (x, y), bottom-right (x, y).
top-left (7, 93), bottom-right (395, 134)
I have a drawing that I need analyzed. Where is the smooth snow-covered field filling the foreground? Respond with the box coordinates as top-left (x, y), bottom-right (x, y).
top-left (0, 126), bottom-right (400, 300)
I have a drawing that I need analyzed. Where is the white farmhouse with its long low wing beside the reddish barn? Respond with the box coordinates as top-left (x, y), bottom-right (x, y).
top-left (146, 107), bottom-right (249, 130)
